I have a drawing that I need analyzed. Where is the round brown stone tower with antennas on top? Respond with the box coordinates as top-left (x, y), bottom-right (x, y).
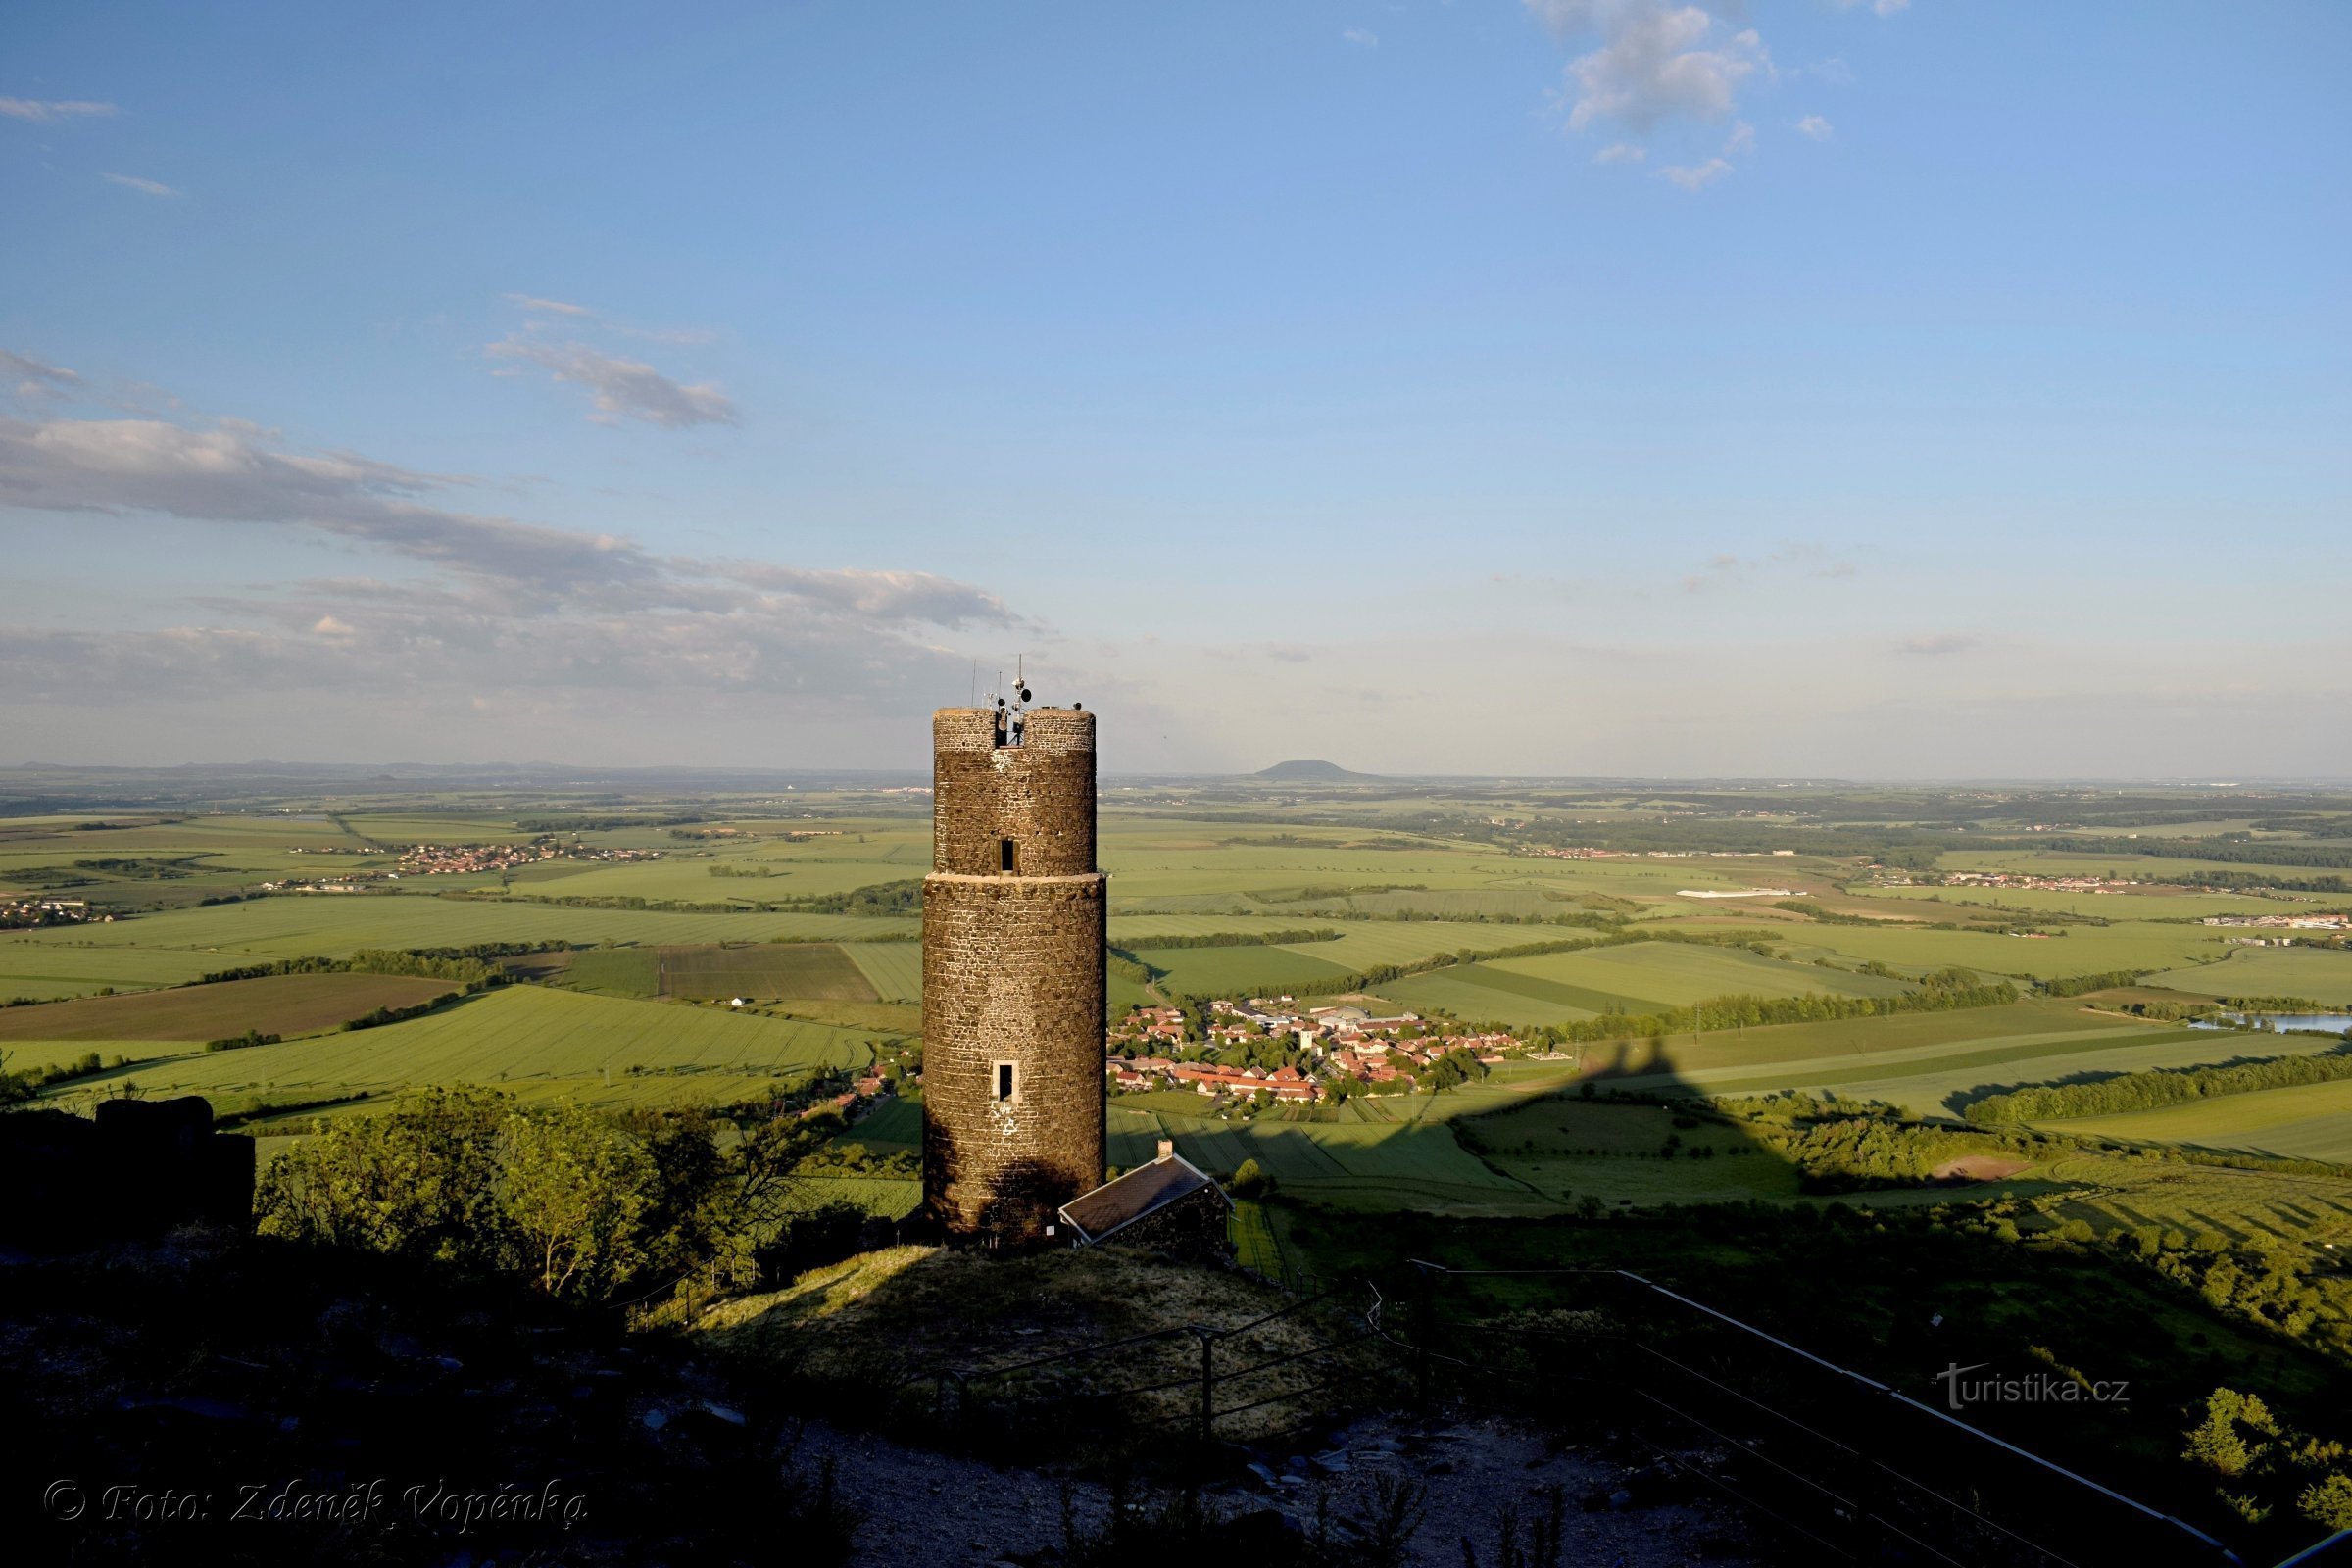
top-left (922, 694), bottom-right (1105, 1242)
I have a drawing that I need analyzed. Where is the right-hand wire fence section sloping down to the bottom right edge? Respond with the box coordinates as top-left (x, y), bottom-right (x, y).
top-left (1371, 1262), bottom-right (2244, 1568)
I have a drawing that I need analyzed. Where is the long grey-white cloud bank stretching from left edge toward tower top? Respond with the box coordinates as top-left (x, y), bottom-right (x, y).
top-left (0, 402), bottom-right (1037, 721)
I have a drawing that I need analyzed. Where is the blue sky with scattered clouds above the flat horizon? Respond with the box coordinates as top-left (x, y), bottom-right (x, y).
top-left (0, 0), bottom-right (2352, 778)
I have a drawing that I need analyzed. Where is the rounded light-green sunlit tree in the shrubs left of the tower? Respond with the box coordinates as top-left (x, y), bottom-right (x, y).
top-left (506, 1104), bottom-right (659, 1300)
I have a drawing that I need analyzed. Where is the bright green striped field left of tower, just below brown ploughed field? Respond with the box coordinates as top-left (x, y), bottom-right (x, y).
top-left (34, 985), bottom-right (872, 1109)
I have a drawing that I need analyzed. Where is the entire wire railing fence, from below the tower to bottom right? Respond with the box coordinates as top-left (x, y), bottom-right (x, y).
top-left (903, 1262), bottom-right (2277, 1568)
